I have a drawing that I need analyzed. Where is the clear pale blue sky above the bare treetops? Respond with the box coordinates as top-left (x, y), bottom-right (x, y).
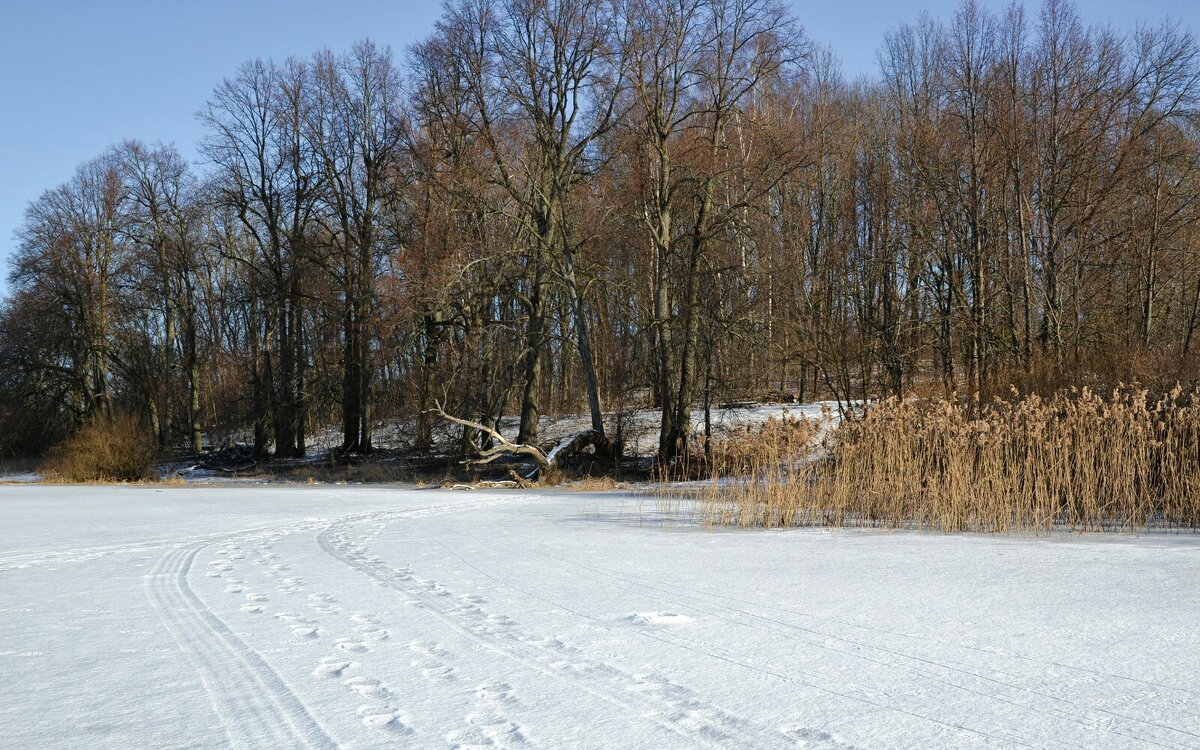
top-left (0, 0), bottom-right (1200, 290)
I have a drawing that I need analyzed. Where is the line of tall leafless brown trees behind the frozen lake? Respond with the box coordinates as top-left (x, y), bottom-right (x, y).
top-left (0, 0), bottom-right (1200, 460)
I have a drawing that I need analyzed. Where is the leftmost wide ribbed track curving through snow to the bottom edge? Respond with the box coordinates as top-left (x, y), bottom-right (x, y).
top-left (145, 542), bottom-right (337, 750)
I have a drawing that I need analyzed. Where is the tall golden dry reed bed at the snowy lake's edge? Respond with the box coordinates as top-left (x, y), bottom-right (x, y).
top-left (703, 388), bottom-right (1200, 532)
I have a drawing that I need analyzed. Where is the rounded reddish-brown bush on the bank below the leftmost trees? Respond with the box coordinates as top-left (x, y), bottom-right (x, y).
top-left (44, 414), bottom-right (157, 482)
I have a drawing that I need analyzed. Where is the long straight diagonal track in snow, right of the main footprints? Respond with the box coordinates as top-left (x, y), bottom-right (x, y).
top-left (317, 514), bottom-right (801, 748)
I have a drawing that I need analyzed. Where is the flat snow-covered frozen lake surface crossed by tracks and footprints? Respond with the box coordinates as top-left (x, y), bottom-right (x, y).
top-left (0, 486), bottom-right (1200, 750)
